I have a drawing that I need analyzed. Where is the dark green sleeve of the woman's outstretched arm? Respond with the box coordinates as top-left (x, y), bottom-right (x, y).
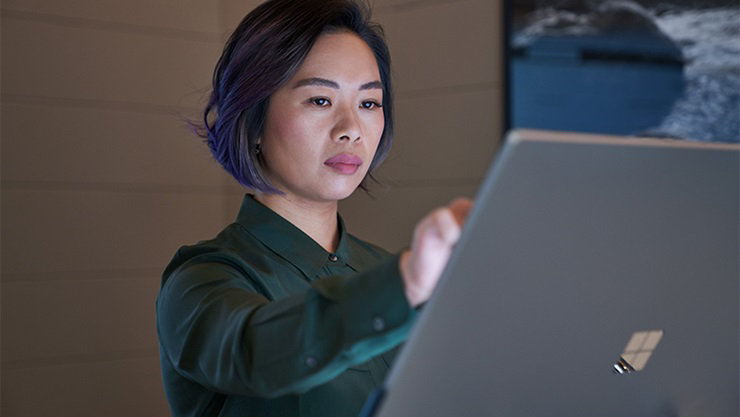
top-left (157, 252), bottom-right (415, 398)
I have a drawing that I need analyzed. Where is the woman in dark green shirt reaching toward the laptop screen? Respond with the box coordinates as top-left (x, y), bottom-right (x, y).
top-left (157, 0), bottom-right (470, 417)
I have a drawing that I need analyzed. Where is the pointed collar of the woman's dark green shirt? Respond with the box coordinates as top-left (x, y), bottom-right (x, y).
top-left (236, 194), bottom-right (356, 279)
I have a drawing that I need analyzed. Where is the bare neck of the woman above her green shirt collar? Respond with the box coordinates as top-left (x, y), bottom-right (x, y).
top-left (254, 193), bottom-right (339, 252)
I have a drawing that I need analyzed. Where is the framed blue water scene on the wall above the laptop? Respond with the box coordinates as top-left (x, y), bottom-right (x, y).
top-left (507, 0), bottom-right (740, 142)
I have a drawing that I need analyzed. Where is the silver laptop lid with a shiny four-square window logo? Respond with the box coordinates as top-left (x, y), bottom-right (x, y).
top-left (366, 130), bottom-right (740, 417)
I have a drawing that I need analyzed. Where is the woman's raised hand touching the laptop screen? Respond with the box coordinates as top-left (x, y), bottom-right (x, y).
top-left (399, 198), bottom-right (473, 307)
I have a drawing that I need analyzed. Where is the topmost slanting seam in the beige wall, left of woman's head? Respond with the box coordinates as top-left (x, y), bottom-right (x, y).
top-left (2, 8), bottom-right (223, 45)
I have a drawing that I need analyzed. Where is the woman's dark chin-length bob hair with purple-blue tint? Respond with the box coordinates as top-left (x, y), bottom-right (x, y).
top-left (199, 0), bottom-right (393, 193)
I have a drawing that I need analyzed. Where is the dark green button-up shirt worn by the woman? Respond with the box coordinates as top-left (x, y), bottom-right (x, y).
top-left (157, 196), bottom-right (414, 417)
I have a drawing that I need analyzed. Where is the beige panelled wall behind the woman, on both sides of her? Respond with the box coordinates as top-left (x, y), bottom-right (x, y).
top-left (0, 0), bottom-right (500, 417)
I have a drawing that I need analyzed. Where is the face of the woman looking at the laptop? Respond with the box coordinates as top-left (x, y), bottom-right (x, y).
top-left (261, 32), bottom-right (385, 202)
